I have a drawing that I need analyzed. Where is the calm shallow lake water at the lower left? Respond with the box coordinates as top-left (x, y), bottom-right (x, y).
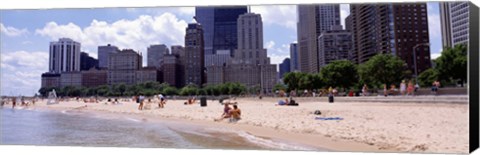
top-left (0, 107), bottom-right (318, 151)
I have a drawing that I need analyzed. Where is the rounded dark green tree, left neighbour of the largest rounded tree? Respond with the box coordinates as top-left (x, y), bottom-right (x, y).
top-left (320, 60), bottom-right (358, 89)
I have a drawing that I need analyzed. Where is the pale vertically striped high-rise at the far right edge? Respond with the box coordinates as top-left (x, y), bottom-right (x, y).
top-left (440, 1), bottom-right (470, 47)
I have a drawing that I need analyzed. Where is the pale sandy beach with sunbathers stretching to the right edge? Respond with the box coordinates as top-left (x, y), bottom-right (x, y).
top-left (21, 98), bottom-right (469, 153)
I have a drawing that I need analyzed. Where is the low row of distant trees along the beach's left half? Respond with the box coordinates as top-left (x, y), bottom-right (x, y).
top-left (38, 82), bottom-right (251, 97)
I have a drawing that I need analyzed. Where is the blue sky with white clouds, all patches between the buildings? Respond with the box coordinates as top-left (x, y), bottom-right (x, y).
top-left (0, 2), bottom-right (441, 96)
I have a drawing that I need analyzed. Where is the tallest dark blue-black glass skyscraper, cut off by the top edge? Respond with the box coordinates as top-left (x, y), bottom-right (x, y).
top-left (195, 6), bottom-right (248, 56)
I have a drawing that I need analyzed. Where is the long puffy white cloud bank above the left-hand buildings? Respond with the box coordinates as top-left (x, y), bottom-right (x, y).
top-left (36, 13), bottom-right (187, 59)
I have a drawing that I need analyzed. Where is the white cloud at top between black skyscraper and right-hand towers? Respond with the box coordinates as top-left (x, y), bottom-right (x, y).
top-left (250, 5), bottom-right (297, 30)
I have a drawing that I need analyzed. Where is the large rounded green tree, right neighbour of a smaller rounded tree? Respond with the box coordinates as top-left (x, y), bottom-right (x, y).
top-left (358, 54), bottom-right (405, 87)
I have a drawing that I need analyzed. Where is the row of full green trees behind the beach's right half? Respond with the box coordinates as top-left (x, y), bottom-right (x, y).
top-left (280, 45), bottom-right (467, 91)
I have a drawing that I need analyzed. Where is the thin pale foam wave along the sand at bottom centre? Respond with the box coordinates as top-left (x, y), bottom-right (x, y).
top-left (207, 128), bottom-right (316, 151)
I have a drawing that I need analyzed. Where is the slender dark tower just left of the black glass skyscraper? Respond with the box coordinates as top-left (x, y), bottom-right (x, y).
top-left (185, 23), bottom-right (205, 87)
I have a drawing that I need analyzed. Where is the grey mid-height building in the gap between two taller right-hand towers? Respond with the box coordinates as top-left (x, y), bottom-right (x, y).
top-left (318, 25), bottom-right (352, 70)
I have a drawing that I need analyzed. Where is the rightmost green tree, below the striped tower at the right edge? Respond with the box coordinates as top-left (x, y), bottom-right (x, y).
top-left (435, 45), bottom-right (467, 87)
